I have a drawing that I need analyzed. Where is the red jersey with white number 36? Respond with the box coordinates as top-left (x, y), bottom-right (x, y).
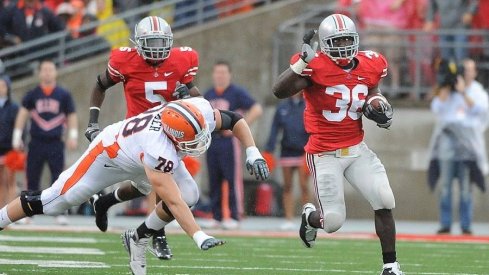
top-left (291, 51), bottom-right (387, 154)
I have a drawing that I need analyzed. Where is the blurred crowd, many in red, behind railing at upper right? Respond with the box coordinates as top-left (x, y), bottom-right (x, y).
top-left (337, 0), bottom-right (489, 99)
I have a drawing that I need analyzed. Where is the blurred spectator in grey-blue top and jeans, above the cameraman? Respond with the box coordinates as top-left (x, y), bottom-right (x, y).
top-left (424, 0), bottom-right (479, 63)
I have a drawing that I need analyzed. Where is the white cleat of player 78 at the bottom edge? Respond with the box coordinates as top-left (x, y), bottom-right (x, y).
top-left (121, 229), bottom-right (149, 275)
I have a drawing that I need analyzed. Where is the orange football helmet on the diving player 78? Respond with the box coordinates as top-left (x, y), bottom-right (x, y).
top-left (161, 100), bottom-right (211, 157)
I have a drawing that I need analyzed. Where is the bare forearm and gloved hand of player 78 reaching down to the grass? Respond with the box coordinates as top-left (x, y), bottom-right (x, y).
top-left (144, 166), bottom-right (224, 250)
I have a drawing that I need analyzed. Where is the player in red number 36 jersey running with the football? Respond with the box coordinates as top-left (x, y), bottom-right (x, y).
top-left (273, 14), bottom-right (402, 275)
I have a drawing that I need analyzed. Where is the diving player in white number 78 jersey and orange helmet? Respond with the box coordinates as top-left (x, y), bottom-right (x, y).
top-left (0, 98), bottom-right (269, 274)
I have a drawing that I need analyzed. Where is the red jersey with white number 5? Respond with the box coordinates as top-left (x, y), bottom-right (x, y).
top-left (108, 47), bottom-right (199, 118)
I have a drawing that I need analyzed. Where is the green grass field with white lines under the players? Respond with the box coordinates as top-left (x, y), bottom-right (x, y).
top-left (0, 231), bottom-right (489, 275)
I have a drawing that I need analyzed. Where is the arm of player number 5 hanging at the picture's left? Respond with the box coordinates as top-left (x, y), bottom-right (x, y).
top-left (85, 70), bottom-right (116, 142)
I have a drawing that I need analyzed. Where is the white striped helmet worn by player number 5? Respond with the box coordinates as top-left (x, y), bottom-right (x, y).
top-left (133, 16), bottom-right (173, 62)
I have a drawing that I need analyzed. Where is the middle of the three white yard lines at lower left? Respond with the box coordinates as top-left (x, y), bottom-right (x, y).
top-left (0, 245), bottom-right (105, 255)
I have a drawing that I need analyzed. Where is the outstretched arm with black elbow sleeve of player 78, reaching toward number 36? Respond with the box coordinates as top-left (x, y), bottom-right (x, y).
top-left (214, 109), bottom-right (270, 180)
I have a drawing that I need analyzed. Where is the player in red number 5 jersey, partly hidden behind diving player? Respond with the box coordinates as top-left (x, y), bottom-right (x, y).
top-left (85, 16), bottom-right (200, 259)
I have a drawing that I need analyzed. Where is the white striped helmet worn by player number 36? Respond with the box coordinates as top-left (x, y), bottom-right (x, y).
top-left (318, 14), bottom-right (360, 66)
